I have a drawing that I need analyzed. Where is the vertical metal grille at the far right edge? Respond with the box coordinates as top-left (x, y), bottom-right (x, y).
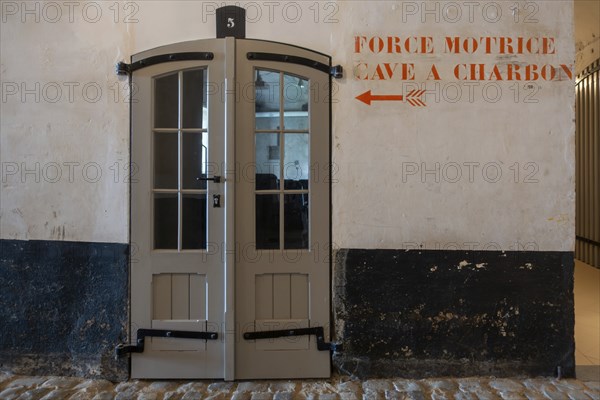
top-left (575, 59), bottom-right (600, 268)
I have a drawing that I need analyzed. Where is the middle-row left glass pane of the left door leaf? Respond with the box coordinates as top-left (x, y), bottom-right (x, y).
top-left (154, 132), bottom-right (179, 189)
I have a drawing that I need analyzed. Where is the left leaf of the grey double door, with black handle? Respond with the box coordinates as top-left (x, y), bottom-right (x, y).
top-left (131, 40), bottom-right (225, 378)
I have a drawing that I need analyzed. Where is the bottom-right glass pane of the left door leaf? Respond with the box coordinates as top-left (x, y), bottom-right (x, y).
top-left (181, 194), bottom-right (206, 249)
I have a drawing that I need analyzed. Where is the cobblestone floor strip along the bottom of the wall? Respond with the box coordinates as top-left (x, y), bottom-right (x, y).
top-left (0, 372), bottom-right (600, 400)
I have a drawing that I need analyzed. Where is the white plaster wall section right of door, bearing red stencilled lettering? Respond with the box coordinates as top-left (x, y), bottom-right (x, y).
top-left (332, 1), bottom-right (575, 250)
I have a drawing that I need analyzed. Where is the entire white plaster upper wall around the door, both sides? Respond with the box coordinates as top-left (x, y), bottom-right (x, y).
top-left (0, 1), bottom-right (574, 250)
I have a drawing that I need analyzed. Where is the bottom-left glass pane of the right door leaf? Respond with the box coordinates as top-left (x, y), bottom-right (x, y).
top-left (256, 194), bottom-right (279, 249)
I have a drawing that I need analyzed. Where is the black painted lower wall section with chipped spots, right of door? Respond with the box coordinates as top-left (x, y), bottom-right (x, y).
top-left (333, 250), bottom-right (575, 378)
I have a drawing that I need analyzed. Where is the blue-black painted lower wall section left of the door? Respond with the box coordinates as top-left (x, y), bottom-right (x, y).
top-left (0, 240), bottom-right (129, 381)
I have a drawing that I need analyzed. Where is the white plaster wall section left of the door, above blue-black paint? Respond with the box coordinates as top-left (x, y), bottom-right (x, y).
top-left (0, 1), bottom-right (130, 242)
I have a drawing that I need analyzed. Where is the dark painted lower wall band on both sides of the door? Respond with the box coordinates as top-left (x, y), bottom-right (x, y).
top-left (0, 240), bottom-right (574, 381)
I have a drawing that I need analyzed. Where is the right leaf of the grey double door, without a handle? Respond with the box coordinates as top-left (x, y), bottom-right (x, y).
top-left (235, 40), bottom-right (330, 379)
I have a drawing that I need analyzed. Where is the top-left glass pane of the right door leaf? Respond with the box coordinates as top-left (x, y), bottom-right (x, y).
top-left (254, 69), bottom-right (281, 130)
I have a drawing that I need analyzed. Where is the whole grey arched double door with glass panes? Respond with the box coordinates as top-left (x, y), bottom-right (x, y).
top-left (131, 38), bottom-right (330, 380)
